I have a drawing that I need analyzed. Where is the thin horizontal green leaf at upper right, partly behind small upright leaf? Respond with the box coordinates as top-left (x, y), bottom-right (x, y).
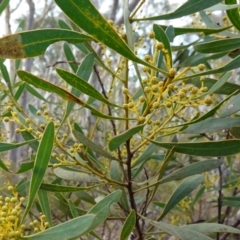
top-left (159, 25), bottom-right (230, 36)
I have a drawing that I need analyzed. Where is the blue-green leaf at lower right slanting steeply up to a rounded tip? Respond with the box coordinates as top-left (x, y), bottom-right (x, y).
top-left (158, 174), bottom-right (204, 221)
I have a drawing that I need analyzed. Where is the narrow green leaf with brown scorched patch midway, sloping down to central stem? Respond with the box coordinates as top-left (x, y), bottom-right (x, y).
top-left (17, 70), bottom-right (129, 120)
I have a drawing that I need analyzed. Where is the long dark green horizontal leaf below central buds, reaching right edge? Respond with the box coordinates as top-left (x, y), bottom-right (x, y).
top-left (148, 139), bottom-right (240, 157)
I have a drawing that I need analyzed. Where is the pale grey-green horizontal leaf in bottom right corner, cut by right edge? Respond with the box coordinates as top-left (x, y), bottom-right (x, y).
top-left (180, 223), bottom-right (240, 234)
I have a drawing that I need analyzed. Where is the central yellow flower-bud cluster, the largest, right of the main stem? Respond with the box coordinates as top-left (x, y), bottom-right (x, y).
top-left (122, 35), bottom-right (213, 140)
